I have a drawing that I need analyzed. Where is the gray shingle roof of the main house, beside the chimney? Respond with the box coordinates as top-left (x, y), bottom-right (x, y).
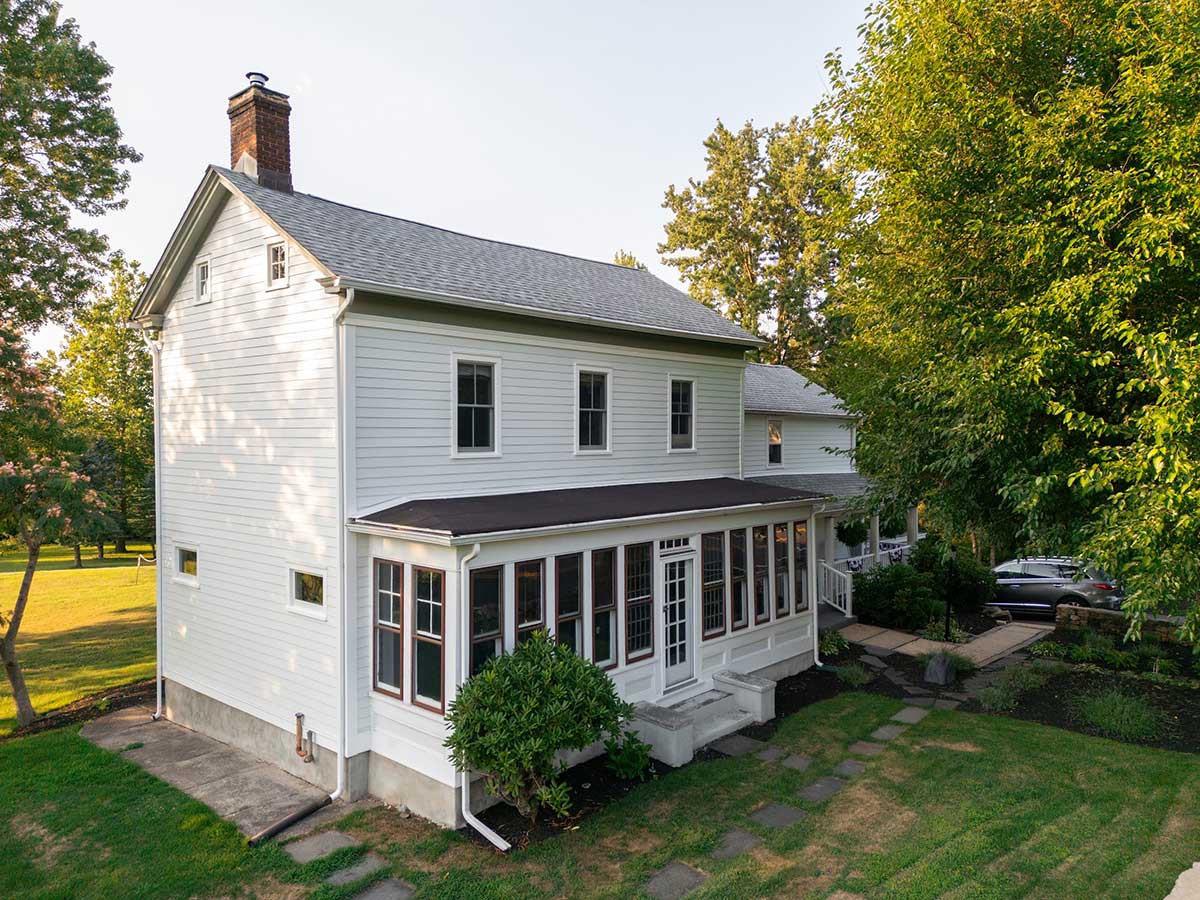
top-left (212, 167), bottom-right (757, 344)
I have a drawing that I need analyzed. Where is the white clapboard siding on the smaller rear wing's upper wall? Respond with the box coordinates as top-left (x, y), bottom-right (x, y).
top-left (742, 413), bottom-right (854, 478)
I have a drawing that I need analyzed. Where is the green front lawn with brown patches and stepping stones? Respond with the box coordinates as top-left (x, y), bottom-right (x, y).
top-left (0, 694), bottom-right (1200, 900)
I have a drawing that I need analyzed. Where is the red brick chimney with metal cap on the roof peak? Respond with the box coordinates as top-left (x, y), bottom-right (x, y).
top-left (229, 72), bottom-right (292, 191)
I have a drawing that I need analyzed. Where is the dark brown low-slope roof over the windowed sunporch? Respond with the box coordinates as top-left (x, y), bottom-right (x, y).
top-left (356, 478), bottom-right (817, 538)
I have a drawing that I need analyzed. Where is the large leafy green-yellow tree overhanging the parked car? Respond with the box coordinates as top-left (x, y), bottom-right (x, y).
top-left (824, 0), bottom-right (1200, 641)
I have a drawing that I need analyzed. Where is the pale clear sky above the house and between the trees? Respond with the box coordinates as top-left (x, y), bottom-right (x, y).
top-left (35, 0), bottom-right (864, 349)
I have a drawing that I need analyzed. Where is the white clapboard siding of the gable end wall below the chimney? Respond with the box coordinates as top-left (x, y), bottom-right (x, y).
top-left (161, 199), bottom-right (338, 746)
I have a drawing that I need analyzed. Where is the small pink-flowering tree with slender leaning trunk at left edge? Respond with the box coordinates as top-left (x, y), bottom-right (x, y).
top-left (0, 323), bottom-right (104, 726)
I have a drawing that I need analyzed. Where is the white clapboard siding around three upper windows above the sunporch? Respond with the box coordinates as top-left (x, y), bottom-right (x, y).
top-left (343, 317), bottom-right (742, 510)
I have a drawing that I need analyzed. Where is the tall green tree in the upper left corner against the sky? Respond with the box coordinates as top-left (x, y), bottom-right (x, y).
top-left (0, 0), bottom-right (140, 328)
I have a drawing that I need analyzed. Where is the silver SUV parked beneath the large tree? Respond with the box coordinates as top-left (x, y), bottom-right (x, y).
top-left (989, 557), bottom-right (1124, 614)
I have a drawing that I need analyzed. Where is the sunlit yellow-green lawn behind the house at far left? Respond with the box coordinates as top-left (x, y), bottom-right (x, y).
top-left (0, 546), bottom-right (155, 734)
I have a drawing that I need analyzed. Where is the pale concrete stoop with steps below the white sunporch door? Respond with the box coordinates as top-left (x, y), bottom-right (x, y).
top-left (634, 672), bottom-right (775, 767)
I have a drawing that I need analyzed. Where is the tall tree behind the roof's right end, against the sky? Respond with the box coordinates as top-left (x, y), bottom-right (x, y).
top-left (659, 119), bottom-right (844, 372)
